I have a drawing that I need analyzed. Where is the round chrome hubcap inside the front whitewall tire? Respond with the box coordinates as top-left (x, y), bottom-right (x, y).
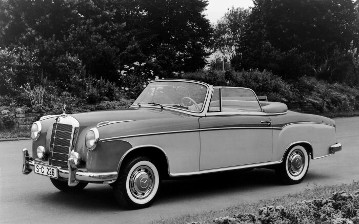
top-left (129, 166), bottom-right (155, 199)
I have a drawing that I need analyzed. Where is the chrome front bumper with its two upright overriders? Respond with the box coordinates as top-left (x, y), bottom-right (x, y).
top-left (22, 148), bottom-right (118, 186)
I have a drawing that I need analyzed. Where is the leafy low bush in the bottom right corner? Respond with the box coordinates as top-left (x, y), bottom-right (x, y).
top-left (213, 191), bottom-right (359, 224)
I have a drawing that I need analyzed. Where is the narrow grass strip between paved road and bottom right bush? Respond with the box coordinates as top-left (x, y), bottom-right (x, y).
top-left (152, 181), bottom-right (359, 224)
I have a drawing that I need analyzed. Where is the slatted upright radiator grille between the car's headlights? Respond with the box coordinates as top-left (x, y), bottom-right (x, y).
top-left (50, 123), bottom-right (73, 168)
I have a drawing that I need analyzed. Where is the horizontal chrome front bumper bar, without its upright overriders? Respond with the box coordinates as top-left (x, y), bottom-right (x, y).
top-left (28, 160), bottom-right (118, 183)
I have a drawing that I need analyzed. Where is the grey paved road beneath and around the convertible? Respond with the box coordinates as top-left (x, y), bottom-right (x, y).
top-left (0, 117), bottom-right (359, 224)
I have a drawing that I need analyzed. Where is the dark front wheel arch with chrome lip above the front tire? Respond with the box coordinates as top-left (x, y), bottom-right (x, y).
top-left (117, 145), bottom-right (170, 178)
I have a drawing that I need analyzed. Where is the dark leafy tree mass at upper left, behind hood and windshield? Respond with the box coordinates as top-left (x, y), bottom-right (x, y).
top-left (0, 0), bottom-right (211, 90)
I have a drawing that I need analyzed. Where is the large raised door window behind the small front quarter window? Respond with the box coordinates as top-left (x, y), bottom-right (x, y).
top-left (221, 88), bottom-right (261, 112)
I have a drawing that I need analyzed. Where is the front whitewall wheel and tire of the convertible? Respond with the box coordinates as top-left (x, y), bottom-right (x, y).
top-left (113, 157), bottom-right (160, 209)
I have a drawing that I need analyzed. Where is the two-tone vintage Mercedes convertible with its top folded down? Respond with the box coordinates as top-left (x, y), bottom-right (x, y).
top-left (22, 80), bottom-right (342, 209)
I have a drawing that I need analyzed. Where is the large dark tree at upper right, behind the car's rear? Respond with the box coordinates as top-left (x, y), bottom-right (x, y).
top-left (236, 0), bottom-right (358, 79)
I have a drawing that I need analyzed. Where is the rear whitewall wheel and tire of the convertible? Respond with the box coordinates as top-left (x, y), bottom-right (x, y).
top-left (276, 145), bottom-right (309, 184)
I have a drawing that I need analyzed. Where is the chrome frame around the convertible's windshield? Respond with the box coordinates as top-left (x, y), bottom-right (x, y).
top-left (130, 79), bottom-right (213, 116)
